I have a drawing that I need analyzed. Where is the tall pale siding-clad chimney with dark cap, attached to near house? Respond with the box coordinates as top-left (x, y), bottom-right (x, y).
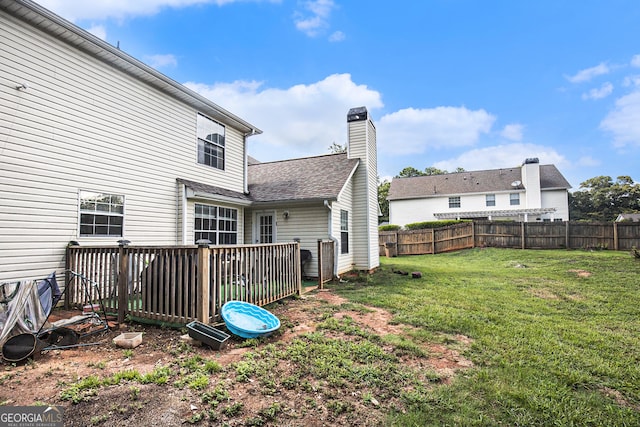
top-left (347, 107), bottom-right (380, 271)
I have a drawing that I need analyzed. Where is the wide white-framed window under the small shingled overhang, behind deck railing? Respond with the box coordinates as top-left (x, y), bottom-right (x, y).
top-left (194, 203), bottom-right (238, 245)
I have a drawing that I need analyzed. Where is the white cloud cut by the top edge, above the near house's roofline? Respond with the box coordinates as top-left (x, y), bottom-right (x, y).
top-left (38, 0), bottom-right (280, 22)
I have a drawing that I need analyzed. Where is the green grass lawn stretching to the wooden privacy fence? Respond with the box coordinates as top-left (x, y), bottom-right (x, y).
top-left (332, 248), bottom-right (640, 426)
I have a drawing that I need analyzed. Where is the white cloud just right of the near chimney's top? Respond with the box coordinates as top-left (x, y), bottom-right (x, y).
top-left (377, 107), bottom-right (495, 155)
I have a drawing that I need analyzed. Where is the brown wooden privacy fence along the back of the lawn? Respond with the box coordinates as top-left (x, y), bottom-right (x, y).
top-left (379, 221), bottom-right (640, 255)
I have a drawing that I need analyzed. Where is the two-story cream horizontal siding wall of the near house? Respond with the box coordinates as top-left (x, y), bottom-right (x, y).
top-left (0, 11), bottom-right (250, 280)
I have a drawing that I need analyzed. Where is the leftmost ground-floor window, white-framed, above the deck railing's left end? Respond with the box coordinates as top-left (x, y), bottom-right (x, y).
top-left (80, 191), bottom-right (124, 237)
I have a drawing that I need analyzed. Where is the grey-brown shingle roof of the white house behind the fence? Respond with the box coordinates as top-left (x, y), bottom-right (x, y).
top-left (387, 165), bottom-right (571, 200)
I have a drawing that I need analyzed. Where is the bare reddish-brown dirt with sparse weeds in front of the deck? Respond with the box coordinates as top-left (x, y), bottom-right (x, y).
top-left (0, 291), bottom-right (473, 426)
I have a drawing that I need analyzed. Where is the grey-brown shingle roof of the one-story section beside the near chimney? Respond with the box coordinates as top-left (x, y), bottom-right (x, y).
top-left (249, 153), bottom-right (359, 202)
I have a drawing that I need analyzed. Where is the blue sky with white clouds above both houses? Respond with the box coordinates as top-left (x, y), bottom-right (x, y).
top-left (38, 0), bottom-right (640, 190)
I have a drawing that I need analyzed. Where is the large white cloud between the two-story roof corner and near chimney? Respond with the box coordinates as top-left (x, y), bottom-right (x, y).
top-left (185, 74), bottom-right (383, 161)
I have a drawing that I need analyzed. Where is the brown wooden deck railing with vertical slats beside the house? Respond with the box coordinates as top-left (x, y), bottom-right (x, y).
top-left (65, 243), bottom-right (302, 324)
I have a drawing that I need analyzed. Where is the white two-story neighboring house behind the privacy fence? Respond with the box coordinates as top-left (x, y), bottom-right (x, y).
top-left (387, 158), bottom-right (571, 226)
